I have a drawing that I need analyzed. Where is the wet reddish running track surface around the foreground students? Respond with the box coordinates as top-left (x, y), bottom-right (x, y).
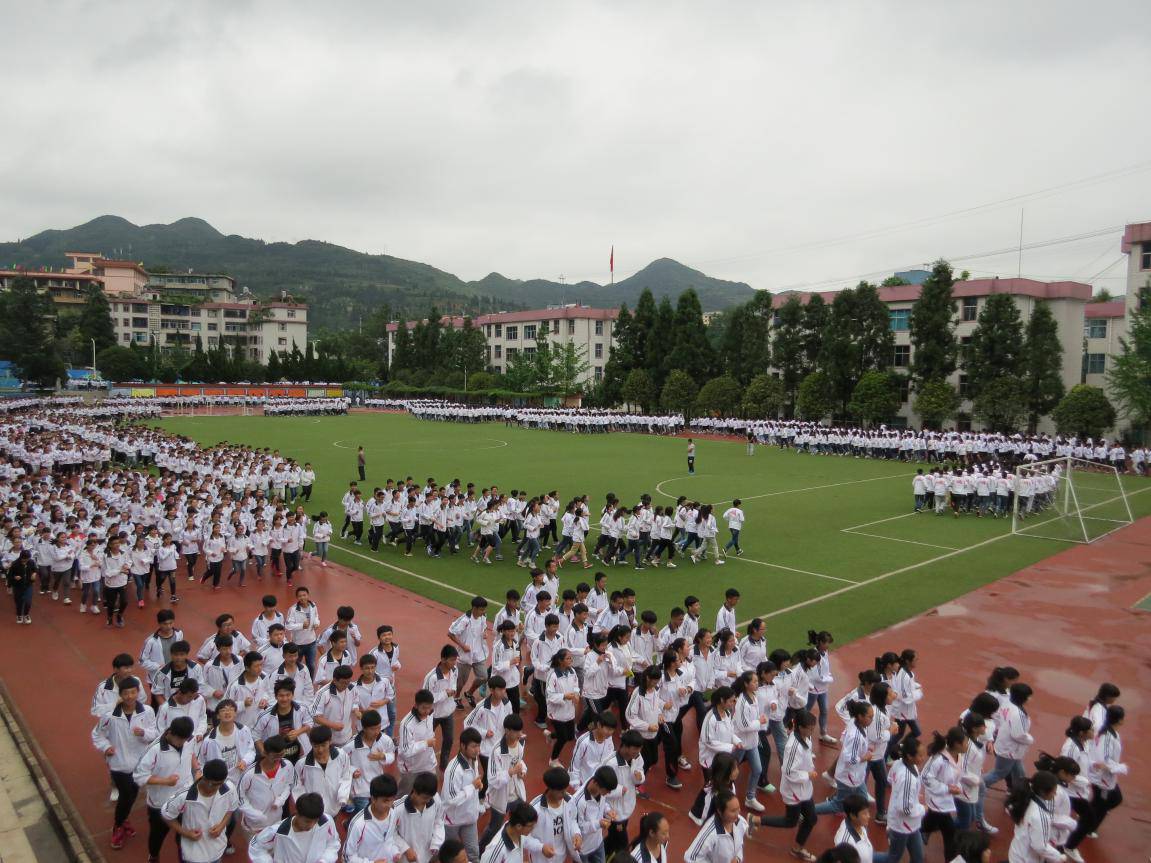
top-left (0, 519), bottom-right (1151, 863)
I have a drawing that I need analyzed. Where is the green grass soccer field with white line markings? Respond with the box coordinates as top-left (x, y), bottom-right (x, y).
top-left (158, 414), bottom-right (1151, 648)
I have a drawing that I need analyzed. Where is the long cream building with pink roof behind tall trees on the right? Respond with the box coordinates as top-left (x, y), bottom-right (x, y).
top-left (772, 278), bottom-right (1091, 429)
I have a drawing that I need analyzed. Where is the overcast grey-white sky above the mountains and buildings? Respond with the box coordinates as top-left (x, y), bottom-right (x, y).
top-left (0, 0), bottom-right (1151, 290)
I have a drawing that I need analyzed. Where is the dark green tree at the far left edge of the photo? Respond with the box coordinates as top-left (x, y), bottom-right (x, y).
top-left (0, 276), bottom-right (64, 387)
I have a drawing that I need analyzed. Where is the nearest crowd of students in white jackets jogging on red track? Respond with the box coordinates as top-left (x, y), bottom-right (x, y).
top-left (83, 582), bottom-right (1127, 863)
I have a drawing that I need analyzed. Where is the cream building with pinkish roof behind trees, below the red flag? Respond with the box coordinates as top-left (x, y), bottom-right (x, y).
top-left (388, 304), bottom-right (619, 383)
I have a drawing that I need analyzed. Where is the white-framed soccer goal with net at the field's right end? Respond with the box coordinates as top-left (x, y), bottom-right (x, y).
top-left (1012, 456), bottom-right (1135, 543)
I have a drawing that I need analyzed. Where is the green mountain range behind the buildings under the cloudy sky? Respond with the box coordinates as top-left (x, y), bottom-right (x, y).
top-left (0, 215), bottom-right (754, 330)
